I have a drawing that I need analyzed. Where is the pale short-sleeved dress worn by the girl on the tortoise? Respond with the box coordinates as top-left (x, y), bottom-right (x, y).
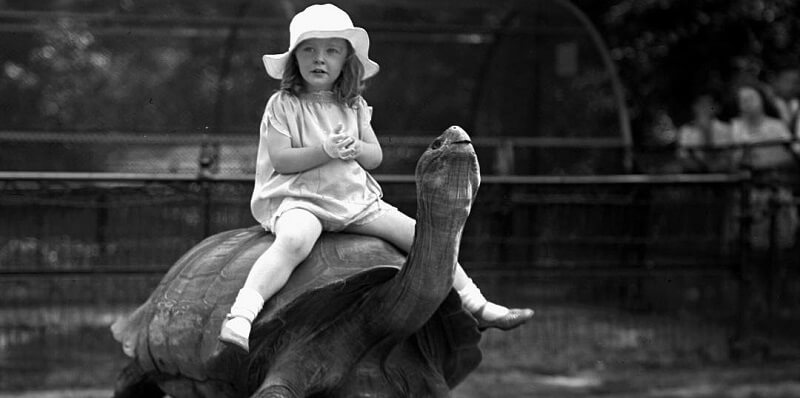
top-left (250, 91), bottom-right (395, 231)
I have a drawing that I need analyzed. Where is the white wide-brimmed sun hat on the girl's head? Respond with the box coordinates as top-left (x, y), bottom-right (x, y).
top-left (262, 4), bottom-right (380, 79)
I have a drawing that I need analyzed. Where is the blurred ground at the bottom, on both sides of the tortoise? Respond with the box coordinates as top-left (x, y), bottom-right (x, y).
top-left (0, 308), bottom-right (800, 398)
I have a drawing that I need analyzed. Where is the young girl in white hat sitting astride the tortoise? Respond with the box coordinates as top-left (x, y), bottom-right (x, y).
top-left (219, 4), bottom-right (533, 351)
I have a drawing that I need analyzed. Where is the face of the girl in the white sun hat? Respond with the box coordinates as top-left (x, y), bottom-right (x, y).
top-left (295, 38), bottom-right (347, 91)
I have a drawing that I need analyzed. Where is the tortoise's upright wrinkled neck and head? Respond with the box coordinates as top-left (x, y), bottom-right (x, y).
top-left (373, 128), bottom-right (480, 339)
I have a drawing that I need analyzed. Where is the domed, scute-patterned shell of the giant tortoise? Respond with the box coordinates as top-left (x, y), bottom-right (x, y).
top-left (117, 227), bottom-right (412, 380)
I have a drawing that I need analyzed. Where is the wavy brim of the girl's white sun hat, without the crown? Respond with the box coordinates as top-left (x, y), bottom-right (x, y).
top-left (261, 28), bottom-right (380, 80)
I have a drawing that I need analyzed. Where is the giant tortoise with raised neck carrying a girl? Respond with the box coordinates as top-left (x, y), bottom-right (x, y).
top-left (112, 126), bottom-right (481, 398)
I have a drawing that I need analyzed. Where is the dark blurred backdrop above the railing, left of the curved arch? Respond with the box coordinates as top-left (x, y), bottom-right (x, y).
top-left (0, 0), bottom-right (619, 135)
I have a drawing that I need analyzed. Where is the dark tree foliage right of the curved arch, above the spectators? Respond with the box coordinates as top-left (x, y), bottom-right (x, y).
top-left (575, 0), bottom-right (800, 140)
